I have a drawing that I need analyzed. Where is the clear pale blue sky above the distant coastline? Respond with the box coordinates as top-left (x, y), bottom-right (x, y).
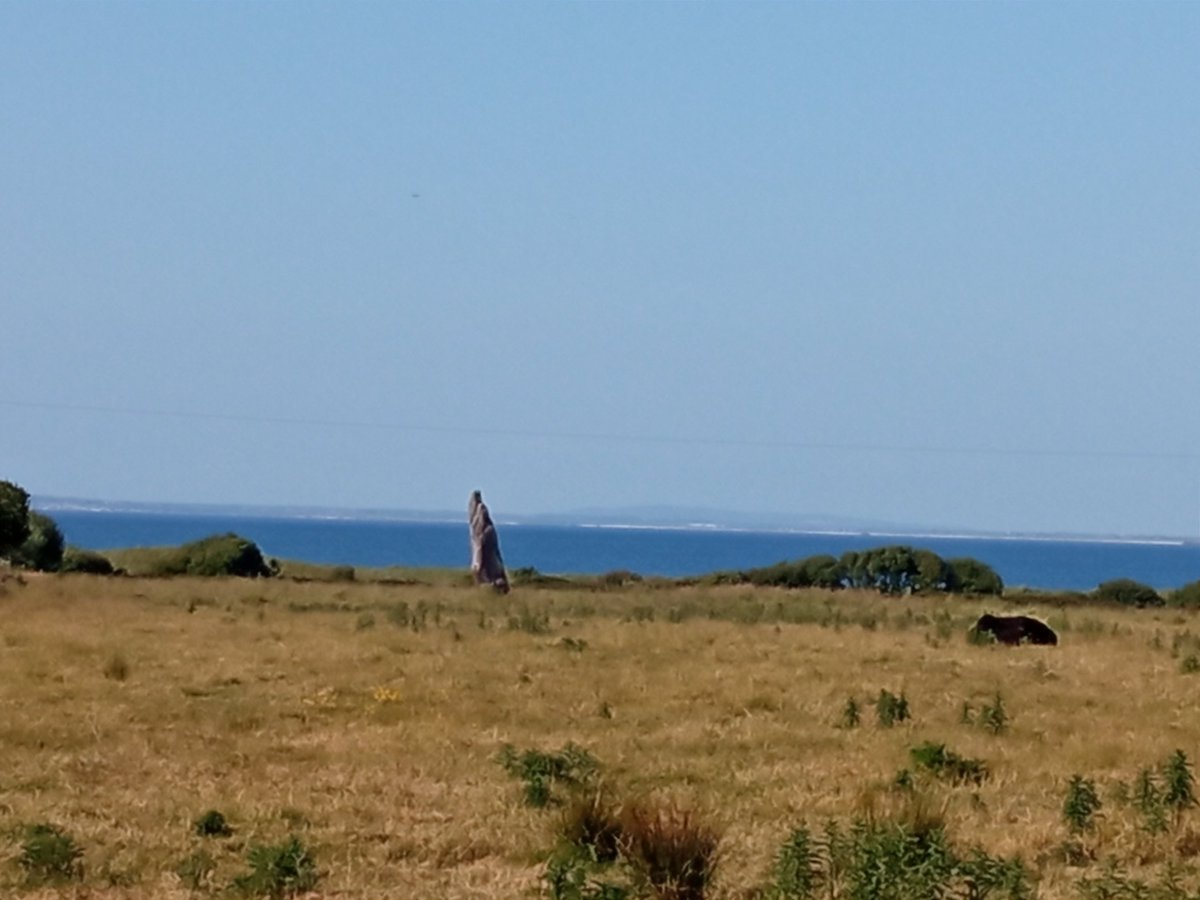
top-left (0, 0), bottom-right (1200, 538)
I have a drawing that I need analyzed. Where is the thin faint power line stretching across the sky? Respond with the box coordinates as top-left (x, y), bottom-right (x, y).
top-left (0, 400), bottom-right (1200, 461)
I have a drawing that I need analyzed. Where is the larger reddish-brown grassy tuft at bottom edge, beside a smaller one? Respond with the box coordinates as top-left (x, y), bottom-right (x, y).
top-left (620, 804), bottom-right (720, 900)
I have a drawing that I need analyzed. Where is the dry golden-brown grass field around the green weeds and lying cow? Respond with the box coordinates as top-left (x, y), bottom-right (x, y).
top-left (0, 576), bottom-right (1200, 900)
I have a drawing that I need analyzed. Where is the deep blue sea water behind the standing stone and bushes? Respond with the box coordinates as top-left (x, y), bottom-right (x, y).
top-left (42, 510), bottom-right (1200, 590)
